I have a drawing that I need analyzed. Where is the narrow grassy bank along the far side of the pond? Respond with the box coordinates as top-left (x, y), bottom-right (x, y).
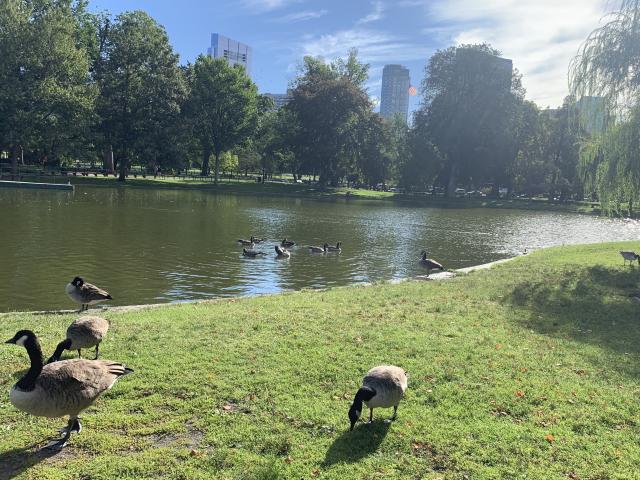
top-left (45, 176), bottom-right (601, 214)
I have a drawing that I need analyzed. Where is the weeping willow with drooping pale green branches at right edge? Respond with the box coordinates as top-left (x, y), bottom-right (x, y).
top-left (569, 0), bottom-right (640, 215)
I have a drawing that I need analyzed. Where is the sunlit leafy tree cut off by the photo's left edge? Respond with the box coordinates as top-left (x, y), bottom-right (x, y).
top-left (0, 0), bottom-right (95, 172)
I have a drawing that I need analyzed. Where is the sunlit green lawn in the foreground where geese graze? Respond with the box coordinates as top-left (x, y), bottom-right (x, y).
top-left (0, 242), bottom-right (640, 480)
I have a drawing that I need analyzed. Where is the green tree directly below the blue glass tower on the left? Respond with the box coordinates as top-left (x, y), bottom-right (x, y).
top-left (187, 55), bottom-right (258, 184)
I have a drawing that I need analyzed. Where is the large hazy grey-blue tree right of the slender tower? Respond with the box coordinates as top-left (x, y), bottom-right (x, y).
top-left (415, 44), bottom-right (524, 196)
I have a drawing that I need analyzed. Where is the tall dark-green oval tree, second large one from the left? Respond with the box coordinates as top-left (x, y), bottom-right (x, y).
top-left (95, 11), bottom-right (185, 181)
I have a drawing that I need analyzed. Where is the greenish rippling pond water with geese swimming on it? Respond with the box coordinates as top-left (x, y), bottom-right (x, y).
top-left (0, 186), bottom-right (640, 311)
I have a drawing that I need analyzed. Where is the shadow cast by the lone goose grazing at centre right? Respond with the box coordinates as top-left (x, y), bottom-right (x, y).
top-left (322, 420), bottom-right (391, 467)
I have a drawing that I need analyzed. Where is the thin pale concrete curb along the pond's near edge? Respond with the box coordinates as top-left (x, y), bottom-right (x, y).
top-left (0, 255), bottom-right (522, 318)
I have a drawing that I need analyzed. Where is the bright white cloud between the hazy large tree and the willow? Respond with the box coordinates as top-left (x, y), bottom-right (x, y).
top-left (423, 0), bottom-right (610, 107)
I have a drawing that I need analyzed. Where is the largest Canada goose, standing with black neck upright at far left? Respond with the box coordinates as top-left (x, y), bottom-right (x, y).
top-left (6, 330), bottom-right (133, 448)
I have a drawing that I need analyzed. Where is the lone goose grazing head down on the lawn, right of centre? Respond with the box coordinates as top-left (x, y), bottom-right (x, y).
top-left (349, 365), bottom-right (407, 430)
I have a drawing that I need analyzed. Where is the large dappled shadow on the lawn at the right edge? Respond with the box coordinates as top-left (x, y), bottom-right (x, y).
top-left (505, 266), bottom-right (640, 375)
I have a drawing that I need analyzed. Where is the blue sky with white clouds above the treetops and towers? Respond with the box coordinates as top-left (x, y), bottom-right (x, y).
top-left (90, 0), bottom-right (613, 110)
